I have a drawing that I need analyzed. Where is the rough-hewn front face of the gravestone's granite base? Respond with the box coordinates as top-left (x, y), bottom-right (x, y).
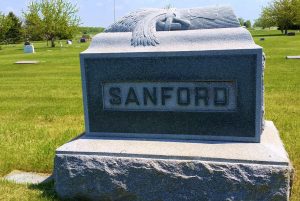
top-left (56, 155), bottom-right (290, 201)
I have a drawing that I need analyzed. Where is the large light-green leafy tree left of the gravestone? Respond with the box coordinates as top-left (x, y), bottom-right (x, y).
top-left (24, 0), bottom-right (80, 47)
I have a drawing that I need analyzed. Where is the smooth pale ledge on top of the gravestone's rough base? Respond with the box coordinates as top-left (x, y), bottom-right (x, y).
top-left (56, 121), bottom-right (289, 166)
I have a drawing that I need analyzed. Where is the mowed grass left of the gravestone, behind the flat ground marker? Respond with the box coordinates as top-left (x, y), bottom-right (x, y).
top-left (0, 42), bottom-right (88, 176)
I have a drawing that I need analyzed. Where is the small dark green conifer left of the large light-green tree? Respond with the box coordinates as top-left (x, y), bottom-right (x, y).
top-left (5, 12), bottom-right (23, 43)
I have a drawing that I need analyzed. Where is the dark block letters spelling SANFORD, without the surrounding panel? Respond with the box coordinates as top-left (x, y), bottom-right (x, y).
top-left (109, 87), bottom-right (229, 106)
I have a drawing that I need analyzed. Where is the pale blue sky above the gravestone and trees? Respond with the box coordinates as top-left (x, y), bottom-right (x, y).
top-left (0, 0), bottom-right (271, 27)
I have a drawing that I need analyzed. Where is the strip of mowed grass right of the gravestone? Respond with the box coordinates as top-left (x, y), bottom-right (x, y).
top-left (252, 30), bottom-right (300, 201)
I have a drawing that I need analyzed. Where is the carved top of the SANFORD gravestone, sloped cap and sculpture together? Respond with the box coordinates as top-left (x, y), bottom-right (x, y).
top-left (84, 6), bottom-right (261, 53)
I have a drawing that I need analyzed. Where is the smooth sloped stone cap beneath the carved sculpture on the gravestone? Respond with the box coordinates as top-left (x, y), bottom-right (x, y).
top-left (81, 27), bottom-right (262, 55)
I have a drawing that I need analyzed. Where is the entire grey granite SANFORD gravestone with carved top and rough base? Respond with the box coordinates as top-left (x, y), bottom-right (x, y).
top-left (55, 7), bottom-right (292, 201)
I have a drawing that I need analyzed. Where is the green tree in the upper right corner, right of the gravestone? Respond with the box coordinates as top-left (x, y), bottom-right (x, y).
top-left (254, 0), bottom-right (300, 34)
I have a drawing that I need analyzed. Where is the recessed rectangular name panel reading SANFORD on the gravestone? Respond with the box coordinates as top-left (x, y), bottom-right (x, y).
top-left (103, 82), bottom-right (237, 112)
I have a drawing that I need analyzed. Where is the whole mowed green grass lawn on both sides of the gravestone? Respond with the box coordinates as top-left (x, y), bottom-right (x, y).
top-left (0, 31), bottom-right (300, 201)
